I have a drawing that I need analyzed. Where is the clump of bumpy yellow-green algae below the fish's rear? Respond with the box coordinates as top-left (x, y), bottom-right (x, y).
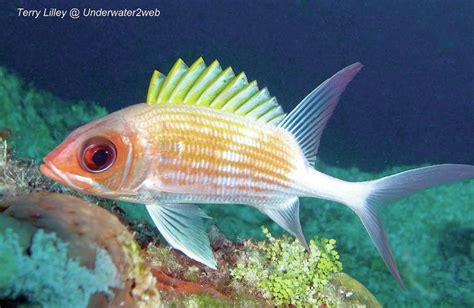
top-left (231, 227), bottom-right (342, 306)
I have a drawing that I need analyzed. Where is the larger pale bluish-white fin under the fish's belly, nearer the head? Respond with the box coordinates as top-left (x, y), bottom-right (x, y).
top-left (146, 204), bottom-right (216, 269)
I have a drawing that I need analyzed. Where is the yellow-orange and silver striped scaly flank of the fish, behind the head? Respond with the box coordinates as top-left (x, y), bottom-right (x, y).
top-left (124, 104), bottom-right (304, 203)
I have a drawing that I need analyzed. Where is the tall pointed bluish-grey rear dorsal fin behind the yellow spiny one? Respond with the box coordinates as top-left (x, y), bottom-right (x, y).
top-left (279, 62), bottom-right (362, 164)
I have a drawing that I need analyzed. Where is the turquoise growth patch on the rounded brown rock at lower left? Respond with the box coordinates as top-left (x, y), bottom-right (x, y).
top-left (0, 226), bottom-right (123, 307)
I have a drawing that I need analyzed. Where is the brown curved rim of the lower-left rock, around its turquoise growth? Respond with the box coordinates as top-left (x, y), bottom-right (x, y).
top-left (0, 193), bottom-right (160, 307)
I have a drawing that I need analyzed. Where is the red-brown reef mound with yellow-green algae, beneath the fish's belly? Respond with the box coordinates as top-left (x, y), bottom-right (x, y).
top-left (146, 226), bottom-right (380, 307)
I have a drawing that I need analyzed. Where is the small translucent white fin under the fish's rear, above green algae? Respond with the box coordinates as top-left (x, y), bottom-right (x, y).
top-left (255, 197), bottom-right (309, 251)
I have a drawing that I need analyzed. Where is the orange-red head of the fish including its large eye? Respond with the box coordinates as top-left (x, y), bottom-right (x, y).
top-left (40, 112), bottom-right (141, 199)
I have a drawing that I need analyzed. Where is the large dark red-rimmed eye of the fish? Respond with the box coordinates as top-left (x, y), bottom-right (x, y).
top-left (80, 137), bottom-right (117, 173)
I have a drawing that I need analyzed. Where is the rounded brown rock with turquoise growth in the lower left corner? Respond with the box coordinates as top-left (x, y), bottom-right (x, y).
top-left (0, 193), bottom-right (160, 307)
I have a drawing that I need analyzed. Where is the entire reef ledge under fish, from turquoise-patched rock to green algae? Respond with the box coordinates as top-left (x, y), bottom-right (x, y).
top-left (0, 192), bottom-right (380, 307)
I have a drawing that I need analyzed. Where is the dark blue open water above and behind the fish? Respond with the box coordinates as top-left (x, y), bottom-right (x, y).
top-left (0, 0), bottom-right (474, 171)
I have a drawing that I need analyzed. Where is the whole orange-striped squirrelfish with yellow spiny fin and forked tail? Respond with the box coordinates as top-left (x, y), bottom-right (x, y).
top-left (40, 58), bottom-right (474, 288)
